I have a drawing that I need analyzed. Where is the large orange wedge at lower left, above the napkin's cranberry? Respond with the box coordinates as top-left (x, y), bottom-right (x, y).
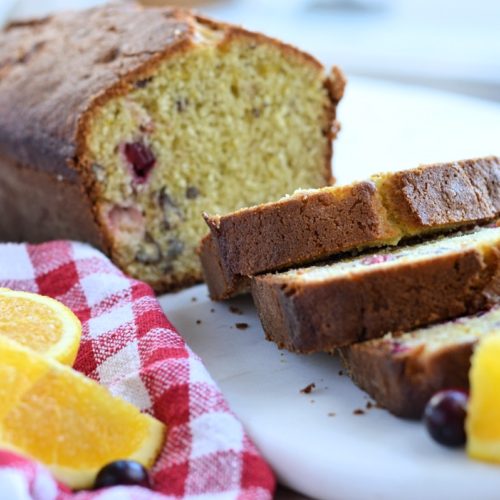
top-left (0, 336), bottom-right (165, 489)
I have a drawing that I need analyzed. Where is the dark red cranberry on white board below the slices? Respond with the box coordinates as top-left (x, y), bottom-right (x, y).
top-left (424, 389), bottom-right (469, 446)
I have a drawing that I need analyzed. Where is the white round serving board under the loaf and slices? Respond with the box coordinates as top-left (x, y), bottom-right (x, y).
top-left (160, 78), bottom-right (500, 500)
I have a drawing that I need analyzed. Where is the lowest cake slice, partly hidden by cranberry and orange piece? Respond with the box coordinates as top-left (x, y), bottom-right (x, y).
top-left (339, 306), bottom-right (500, 418)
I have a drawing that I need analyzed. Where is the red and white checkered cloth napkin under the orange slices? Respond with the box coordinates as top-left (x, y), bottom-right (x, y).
top-left (0, 242), bottom-right (275, 500)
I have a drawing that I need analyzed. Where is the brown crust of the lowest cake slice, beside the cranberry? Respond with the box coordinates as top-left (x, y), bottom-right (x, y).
top-left (339, 340), bottom-right (475, 419)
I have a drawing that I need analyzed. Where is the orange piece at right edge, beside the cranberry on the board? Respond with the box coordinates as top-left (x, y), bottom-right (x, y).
top-left (466, 329), bottom-right (500, 463)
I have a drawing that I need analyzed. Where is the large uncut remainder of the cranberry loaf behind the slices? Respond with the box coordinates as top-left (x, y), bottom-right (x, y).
top-left (0, 2), bottom-right (345, 291)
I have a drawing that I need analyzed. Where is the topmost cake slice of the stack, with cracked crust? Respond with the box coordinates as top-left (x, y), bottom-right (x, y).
top-left (200, 157), bottom-right (500, 300)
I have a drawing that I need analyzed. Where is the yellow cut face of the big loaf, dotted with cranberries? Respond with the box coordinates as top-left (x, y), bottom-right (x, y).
top-left (87, 24), bottom-right (334, 290)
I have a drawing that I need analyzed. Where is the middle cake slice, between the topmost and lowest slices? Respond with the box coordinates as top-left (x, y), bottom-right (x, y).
top-left (252, 227), bottom-right (500, 353)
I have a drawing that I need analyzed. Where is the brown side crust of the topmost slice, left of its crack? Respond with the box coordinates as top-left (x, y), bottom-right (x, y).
top-left (205, 182), bottom-right (395, 276)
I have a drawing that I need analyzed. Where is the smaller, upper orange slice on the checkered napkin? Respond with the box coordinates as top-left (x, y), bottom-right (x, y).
top-left (0, 288), bottom-right (82, 365)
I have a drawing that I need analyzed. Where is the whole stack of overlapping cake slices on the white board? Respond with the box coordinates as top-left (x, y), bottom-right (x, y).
top-left (200, 157), bottom-right (500, 418)
